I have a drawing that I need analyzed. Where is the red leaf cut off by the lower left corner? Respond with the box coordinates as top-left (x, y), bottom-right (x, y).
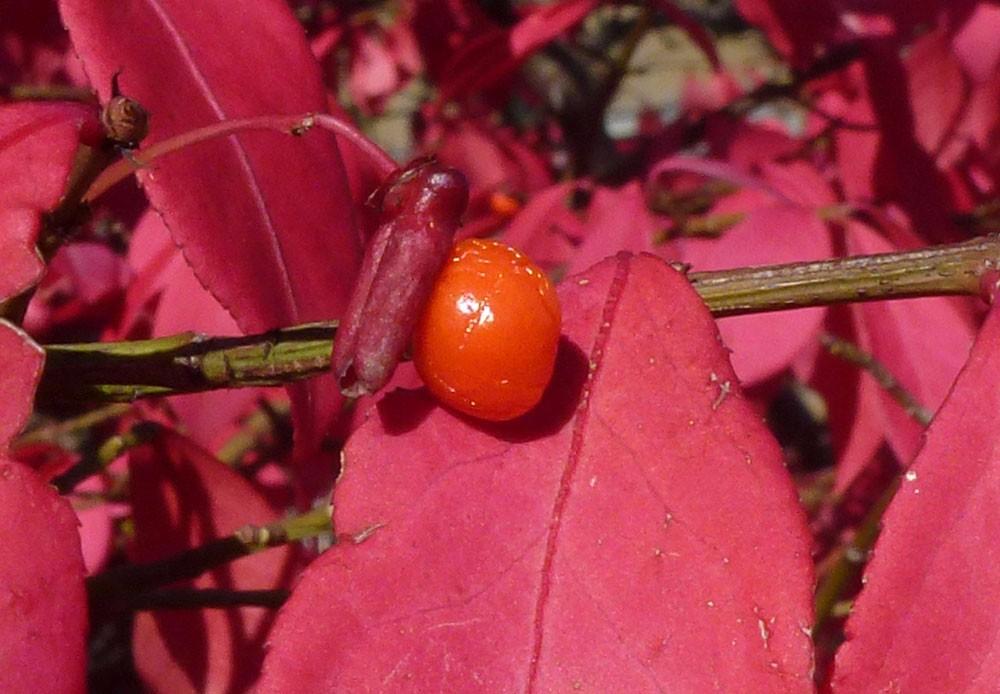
top-left (0, 458), bottom-right (87, 694)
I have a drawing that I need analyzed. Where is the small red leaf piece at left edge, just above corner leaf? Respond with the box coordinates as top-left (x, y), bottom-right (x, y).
top-left (0, 320), bottom-right (45, 454)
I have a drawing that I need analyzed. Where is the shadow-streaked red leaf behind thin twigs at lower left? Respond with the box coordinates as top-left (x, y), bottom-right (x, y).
top-left (129, 433), bottom-right (294, 692)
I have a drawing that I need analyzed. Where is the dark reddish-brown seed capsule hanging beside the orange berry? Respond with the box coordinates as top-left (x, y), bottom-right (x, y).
top-left (333, 158), bottom-right (469, 397)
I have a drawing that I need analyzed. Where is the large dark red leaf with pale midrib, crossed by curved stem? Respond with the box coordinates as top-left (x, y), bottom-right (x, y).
top-left (60, 0), bottom-right (360, 468)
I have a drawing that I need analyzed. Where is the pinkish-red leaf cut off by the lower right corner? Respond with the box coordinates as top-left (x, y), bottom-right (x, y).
top-left (833, 296), bottom-right (1000, 692)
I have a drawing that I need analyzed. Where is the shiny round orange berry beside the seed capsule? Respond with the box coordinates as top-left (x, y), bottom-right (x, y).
top-left (413, 239), bottom-right (562, 421)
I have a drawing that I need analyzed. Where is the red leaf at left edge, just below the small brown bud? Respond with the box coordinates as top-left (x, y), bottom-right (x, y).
top-left (0, 103), bottom-right (100, 301)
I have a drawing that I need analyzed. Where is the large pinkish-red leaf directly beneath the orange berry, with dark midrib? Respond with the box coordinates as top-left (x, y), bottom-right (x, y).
top-left (260, 255), bottom-right (812, 692)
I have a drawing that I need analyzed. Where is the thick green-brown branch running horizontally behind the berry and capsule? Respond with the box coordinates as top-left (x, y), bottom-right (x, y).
top-left (38, 236), bottom-right (1000, 403)
